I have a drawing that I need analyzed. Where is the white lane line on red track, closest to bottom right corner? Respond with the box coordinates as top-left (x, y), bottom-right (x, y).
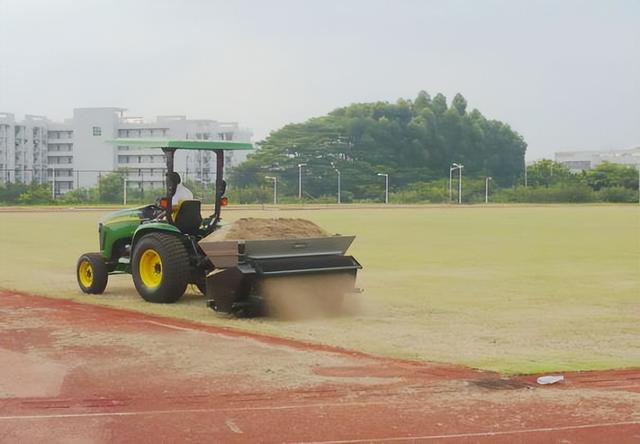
top-left (300, 421), bottom-right (640, 444)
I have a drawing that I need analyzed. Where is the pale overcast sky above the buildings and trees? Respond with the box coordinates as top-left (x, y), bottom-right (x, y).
top-left (0, 0), bottom-right (640, 160)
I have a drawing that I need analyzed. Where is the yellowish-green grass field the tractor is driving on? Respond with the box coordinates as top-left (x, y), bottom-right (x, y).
top-left (0, 206), bottom-right (640, 373)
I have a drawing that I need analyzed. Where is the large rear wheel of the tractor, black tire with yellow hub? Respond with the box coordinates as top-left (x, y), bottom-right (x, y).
top-left (131, 233), bottom-right (190, 304)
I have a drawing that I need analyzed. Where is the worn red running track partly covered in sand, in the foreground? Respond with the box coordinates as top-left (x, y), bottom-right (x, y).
top-left (0, 291), bottom-right (640, 443)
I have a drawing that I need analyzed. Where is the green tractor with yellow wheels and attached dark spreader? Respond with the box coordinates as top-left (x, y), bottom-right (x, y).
top-left (77, 139), bottom-right (362, 315)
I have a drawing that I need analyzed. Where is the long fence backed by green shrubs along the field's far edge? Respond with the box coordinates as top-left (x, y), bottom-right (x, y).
top-left (0, 160), bottom-right (640, 205)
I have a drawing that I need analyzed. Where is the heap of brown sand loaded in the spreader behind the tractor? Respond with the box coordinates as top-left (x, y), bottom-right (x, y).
top-left (206, 217), bottom-right (330, 240)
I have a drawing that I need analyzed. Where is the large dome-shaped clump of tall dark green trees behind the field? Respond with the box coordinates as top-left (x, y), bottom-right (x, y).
top-left (232, 91), bottom-right (527, 198)
